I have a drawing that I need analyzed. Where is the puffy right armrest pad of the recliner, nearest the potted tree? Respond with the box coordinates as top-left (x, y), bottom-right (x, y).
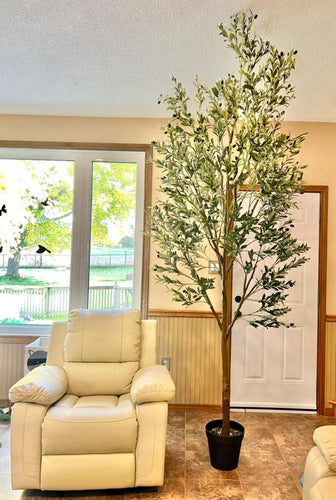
top-left (130, 365), bottom-right (175, 404)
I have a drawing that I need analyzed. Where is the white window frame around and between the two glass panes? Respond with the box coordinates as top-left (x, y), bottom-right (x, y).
top-left (0, 148), bottom-right (146, 336)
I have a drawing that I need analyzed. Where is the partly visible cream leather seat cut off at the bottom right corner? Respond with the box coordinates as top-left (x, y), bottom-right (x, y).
top-left (302, 425), bottom-right (336, 500)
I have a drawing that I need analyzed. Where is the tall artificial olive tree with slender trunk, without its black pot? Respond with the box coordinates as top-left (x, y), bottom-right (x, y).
top-left (151, 9), bottom-right (308, 436)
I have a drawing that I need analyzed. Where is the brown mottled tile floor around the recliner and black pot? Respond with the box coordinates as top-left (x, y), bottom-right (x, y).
top-left (0, 412), bottom-right (335, 500)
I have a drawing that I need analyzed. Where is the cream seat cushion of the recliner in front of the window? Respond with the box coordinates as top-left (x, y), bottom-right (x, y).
top-left (42, 394), bottom-right (137, 455)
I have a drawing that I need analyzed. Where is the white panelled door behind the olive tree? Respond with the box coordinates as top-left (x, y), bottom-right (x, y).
top-left (231, 193), bottom-right (320, 410)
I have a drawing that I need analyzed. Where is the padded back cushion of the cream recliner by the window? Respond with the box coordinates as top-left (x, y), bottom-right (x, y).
top-left (64, 309), bottom-right (141, 396)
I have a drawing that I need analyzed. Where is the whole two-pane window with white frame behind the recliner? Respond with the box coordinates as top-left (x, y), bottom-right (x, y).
top-left (0, 149), bottom-right (144, 328)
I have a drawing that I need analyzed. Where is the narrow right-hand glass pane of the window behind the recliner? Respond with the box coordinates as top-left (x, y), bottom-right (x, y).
top-left (88, 162), bottom-right (137, 310)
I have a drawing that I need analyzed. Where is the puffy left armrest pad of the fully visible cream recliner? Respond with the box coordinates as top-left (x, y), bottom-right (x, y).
top-left (9, 365), bottom-right (68, 406)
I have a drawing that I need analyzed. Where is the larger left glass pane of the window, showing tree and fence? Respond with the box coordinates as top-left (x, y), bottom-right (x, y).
top-left (0, 159), bottom-right (74, 324)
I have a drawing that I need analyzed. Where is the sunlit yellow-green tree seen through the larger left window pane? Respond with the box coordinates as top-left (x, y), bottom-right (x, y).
top-left (0, 160), bottom-right (72, 279)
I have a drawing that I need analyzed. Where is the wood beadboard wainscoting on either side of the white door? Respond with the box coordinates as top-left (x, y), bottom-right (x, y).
top-left (149, 311), bottom-right (336, 415)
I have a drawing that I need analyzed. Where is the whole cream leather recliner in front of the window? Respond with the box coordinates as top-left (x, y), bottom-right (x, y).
top-left (9, 310), bottom-right (175, 490)
